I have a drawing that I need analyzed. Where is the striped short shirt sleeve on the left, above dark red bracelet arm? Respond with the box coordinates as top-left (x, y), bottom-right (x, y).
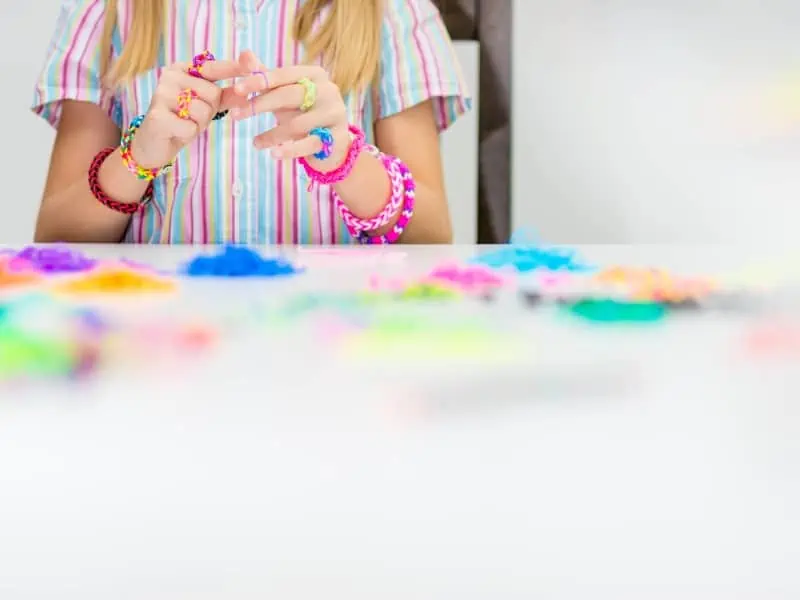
top-left (31, 0), bottom-right (120, 127)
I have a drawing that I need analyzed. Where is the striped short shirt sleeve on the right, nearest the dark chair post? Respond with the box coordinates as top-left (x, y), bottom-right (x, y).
top-left (377, 0), bottom-right (472, 131)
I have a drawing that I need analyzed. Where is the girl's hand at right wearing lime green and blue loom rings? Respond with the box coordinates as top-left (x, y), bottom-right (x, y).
top-left (232, 52), bottom-right (350, 168)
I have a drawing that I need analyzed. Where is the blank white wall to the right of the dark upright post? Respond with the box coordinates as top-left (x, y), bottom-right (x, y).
top-left (513, 0), bottom-right (800, 243)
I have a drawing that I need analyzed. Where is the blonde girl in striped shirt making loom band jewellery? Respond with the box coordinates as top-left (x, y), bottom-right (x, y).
top-left (33, 0), bottom-right (469, 244)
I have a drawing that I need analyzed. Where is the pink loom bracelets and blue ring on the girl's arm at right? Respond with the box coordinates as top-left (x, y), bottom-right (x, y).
top-left (300, 126), bottom-right (416, 244)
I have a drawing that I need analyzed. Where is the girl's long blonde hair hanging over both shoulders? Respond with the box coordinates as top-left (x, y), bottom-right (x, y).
top-left (101, 0), bottom-right (383, 93)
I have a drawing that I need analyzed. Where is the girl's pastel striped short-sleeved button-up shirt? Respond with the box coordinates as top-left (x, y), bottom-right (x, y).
top-left (33, 0), bottom-right (470, 244)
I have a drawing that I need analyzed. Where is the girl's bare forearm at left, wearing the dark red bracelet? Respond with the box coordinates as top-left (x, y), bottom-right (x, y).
top-left (35, 152), bottom-right (148, 243)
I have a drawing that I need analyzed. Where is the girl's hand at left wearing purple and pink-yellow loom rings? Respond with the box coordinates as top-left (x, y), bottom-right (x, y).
top-left (131, 60), bottom-right (248, 169)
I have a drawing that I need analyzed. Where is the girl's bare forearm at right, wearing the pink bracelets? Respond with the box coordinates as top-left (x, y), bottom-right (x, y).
top-left (334, 152), bottom-right (452, 244)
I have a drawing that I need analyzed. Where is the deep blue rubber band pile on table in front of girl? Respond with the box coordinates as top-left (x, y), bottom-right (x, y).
top-left (185, 246), bottom-right (300, 277)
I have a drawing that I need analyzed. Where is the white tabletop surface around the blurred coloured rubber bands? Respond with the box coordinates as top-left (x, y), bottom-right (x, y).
top-left (0, 247), bottom-right (800, 600)
